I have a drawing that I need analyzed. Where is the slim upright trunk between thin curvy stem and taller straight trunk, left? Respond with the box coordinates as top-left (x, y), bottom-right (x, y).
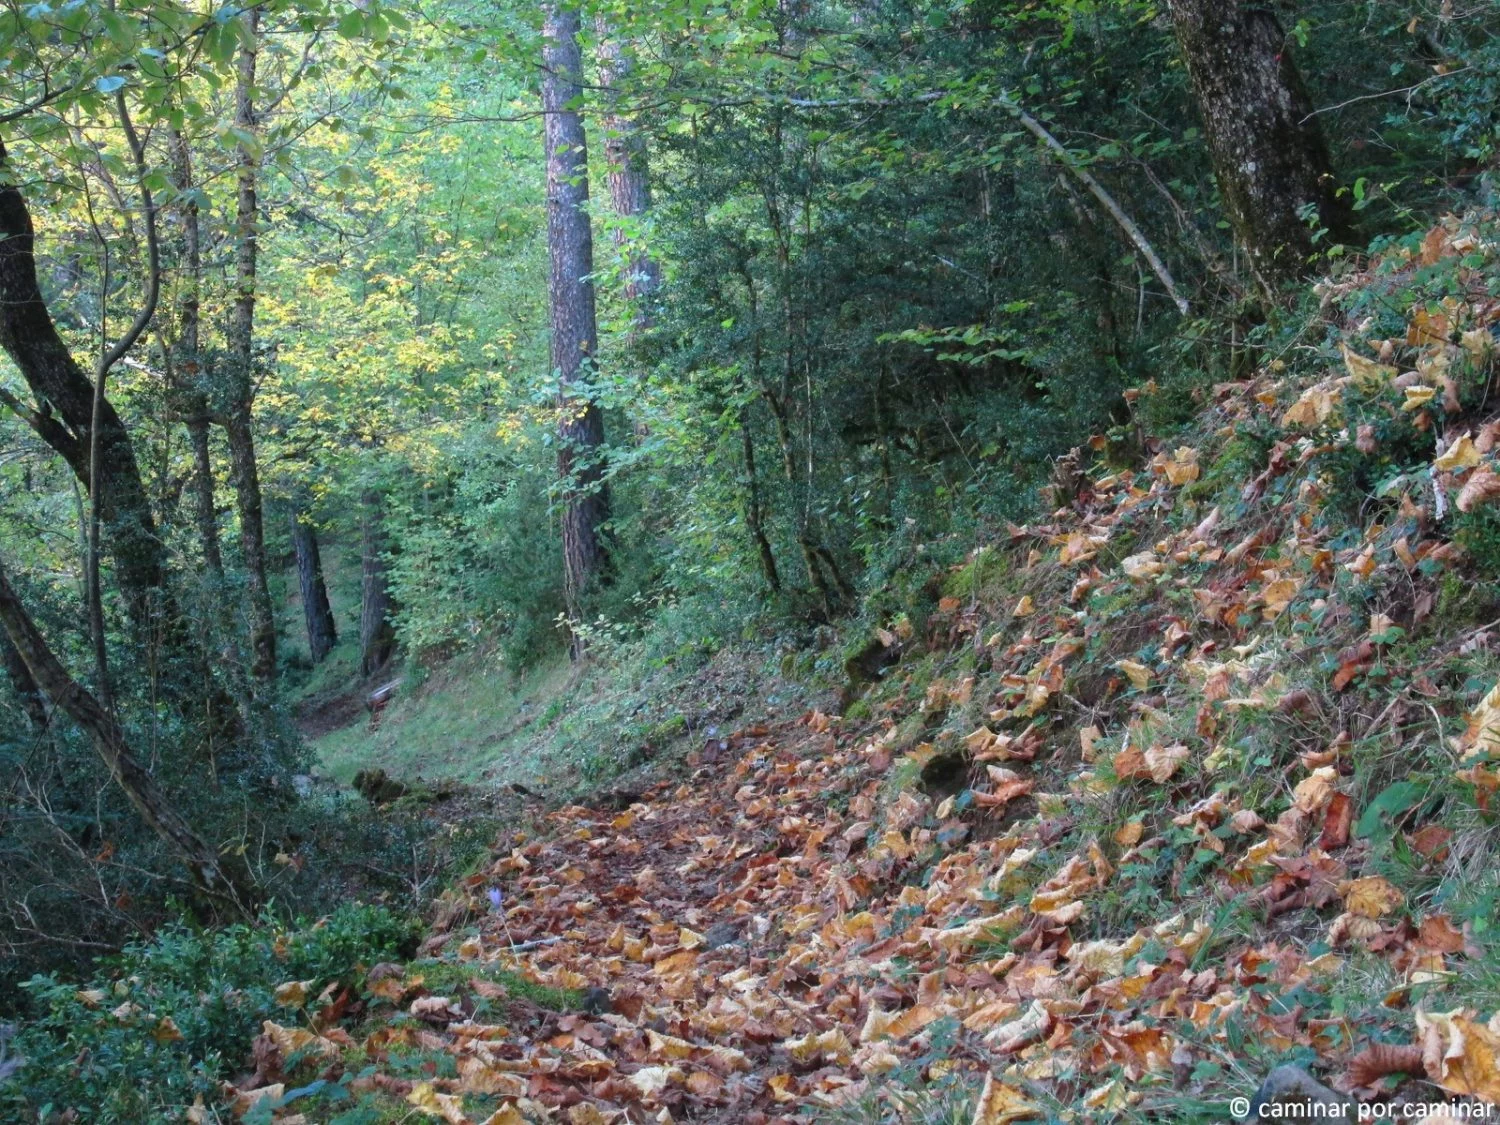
top-left (171, 131), bottom-right (224, 579)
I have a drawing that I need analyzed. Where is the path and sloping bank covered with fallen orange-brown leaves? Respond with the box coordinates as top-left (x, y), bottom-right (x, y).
top-left (222, 219), bottom-right (1500, 1125)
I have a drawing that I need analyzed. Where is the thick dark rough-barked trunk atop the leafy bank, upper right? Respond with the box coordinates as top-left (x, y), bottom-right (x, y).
top-left (1167, 0), bottom-right (1350, 294)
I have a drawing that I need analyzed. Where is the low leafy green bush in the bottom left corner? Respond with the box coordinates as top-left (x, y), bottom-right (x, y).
top-left (0, 905), bottom-right (420, 1125)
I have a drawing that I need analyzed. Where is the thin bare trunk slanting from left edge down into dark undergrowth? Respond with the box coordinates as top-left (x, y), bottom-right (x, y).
top-left (0, 567), bottom-right (245, 914)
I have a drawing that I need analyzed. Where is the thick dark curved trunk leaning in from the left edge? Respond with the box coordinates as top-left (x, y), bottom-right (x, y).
top-left (0, 144), bottom-right (171, 635)
